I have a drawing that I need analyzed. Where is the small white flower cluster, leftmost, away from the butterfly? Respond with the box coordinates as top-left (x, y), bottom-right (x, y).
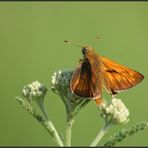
top-left (22, 81), bottom-right (47, 99)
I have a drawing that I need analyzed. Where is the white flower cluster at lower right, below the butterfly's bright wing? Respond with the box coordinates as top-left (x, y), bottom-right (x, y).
top-left (100, 98), bottom-right (129, 124)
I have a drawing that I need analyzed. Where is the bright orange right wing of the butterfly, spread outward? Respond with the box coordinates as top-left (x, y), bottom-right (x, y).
top-left (100, 57), bottom-right (144, 95)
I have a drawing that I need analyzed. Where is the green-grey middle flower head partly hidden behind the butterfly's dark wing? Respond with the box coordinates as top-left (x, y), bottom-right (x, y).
top-left (51, 70), bottom-right (90, 117)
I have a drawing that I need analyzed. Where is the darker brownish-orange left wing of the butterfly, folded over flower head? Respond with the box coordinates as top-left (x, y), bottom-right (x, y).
top-left (70, 60), bottom-right (101, 98)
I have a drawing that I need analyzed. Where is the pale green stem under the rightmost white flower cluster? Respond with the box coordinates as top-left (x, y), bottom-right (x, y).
top-left (90, 122), bottom-right (112, 146)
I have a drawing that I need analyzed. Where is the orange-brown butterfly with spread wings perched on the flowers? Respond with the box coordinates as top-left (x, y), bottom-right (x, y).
top-left (65, 41), bottom-right (144, 104)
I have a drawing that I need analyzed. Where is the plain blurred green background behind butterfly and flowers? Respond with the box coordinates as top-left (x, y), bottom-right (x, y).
top-left (0, 2), bottom-right (148, 146)
